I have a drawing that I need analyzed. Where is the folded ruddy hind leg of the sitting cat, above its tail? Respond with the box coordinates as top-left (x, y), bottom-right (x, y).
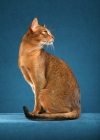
top-left (39, 89), bottom-right (71, 114)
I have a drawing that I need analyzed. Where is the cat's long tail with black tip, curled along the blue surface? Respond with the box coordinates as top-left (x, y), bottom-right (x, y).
top-left (23, 106), bottom-right (81, 120)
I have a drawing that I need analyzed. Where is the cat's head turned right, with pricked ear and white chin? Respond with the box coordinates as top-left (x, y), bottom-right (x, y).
top-left (25, 18), bottom-right (54, 46)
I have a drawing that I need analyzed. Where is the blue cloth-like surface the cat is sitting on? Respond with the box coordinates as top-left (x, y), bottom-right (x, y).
top-left (0, 113), bottom-right (100, 140)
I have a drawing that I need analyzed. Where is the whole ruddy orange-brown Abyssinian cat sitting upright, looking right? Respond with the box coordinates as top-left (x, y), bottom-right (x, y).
top-left (18, 18), bottom-right (81, 120)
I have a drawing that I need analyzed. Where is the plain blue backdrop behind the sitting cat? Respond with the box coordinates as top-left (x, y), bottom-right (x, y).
top-left (0, 0), bottom-right (100, 113)
